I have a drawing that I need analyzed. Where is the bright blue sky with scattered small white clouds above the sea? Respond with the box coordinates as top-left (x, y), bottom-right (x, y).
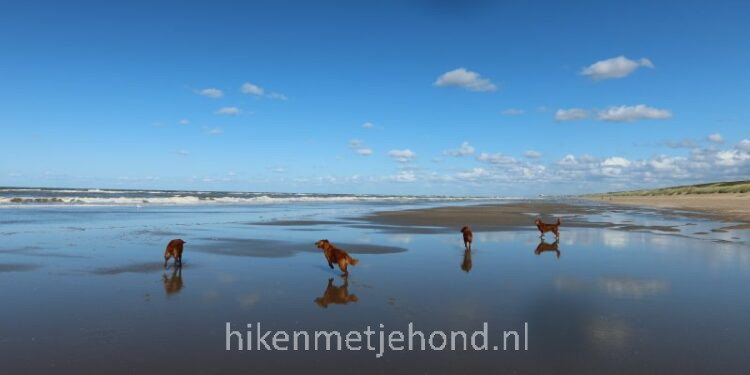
top-left (0, 0), bottom-right (750, 196)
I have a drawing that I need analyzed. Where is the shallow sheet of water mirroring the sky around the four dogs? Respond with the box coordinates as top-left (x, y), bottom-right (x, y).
top-left (0, 205), bottom-right (750, 374)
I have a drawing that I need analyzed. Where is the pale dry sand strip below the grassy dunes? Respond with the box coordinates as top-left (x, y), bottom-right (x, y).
top-left (584, 193), bottom-right (750, 229)
